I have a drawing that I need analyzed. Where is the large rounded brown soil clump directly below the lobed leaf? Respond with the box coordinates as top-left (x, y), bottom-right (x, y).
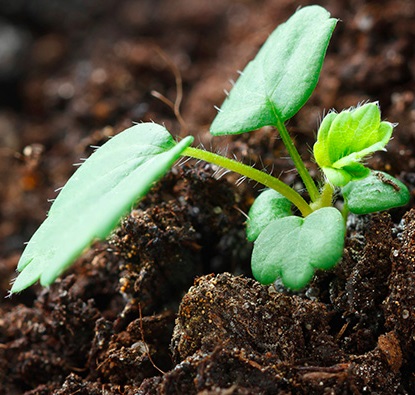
top-left (172, 274), bottom-right (340, 364)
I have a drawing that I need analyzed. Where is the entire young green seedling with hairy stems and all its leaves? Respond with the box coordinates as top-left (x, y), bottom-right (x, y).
top-left (11, 6), bottom-right (409, 293)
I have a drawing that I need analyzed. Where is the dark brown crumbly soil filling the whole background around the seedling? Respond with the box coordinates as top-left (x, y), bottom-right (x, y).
top-left (0, 0), bottom-right (415, 395)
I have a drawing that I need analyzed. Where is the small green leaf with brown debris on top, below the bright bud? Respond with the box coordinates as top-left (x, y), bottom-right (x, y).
top-left (342, 171), bottom-right (410, 214)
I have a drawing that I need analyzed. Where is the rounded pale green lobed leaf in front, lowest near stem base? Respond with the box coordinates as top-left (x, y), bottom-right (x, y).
top-left (252, 207), bottom-right (346, 289)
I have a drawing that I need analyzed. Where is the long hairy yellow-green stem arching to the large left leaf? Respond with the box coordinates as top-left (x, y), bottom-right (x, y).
top-left (182, 147), bottom-right (312, 217)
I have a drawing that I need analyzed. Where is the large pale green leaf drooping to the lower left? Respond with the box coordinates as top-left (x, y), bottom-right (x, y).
top-left (11, 123), bottom-right (193, 293)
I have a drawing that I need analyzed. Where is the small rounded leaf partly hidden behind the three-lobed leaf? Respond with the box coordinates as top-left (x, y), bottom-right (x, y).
top-left (246, 189), bottom-right (292, 241)
